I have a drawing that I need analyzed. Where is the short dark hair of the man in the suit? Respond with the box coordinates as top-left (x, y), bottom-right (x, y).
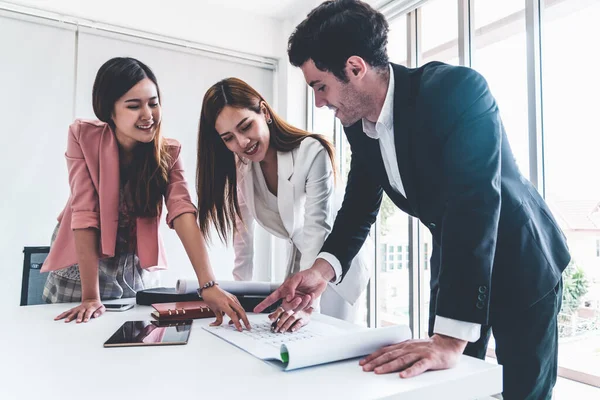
top-left (288, 0), bottom-right (389, 82)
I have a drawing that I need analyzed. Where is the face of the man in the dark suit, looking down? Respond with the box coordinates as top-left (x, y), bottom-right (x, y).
top-left (300, 59), bottom-right (369, 126)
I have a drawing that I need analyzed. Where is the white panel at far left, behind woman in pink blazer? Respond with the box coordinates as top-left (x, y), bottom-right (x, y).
top-left (0, 12), bottom-right (75, 305)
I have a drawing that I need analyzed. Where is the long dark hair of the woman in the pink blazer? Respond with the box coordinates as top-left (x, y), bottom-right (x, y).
top-left (92, 57), bottom-right (170, 217)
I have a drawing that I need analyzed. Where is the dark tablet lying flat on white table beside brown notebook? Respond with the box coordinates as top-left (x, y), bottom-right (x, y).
top-left (104, 320), bottom-right (193, 347)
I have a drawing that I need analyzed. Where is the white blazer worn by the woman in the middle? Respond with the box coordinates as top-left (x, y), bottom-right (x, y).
top-left (233, 138), bottom-right (372, 304)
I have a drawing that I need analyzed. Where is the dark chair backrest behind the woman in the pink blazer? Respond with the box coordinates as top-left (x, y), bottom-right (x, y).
top-left (21, 246), bottom-right (50, 306)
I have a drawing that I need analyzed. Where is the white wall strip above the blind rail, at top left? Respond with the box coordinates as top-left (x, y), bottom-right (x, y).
top-left (6, 0), bottom-right (281, 57)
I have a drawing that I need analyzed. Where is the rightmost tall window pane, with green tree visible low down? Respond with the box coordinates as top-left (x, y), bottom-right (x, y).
top-left (542, 0), bottom-right (600, 379)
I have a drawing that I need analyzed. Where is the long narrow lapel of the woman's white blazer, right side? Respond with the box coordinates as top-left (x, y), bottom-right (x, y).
top-left (277, 151), bottom-right (295, 238)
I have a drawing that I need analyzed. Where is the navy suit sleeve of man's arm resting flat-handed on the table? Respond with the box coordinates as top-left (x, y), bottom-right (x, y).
top-left (430, 68), bottom-right (502, 324)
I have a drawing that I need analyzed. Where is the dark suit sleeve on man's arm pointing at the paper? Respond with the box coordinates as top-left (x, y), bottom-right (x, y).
top-left (321, 149), bottom-right (383, 283)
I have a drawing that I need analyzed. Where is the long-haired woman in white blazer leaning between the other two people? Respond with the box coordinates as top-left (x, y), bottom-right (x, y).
top-left (196, 78), bottom-right (370, 331)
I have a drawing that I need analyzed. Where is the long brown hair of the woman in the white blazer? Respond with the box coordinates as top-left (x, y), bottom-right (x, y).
top-left (196, 78), bottom-right (335, 241)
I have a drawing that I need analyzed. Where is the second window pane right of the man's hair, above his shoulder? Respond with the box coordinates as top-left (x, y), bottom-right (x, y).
top-left (418, 0), bottom-right (458, 65)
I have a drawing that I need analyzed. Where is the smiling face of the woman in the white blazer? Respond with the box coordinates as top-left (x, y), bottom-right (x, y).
top-left (215, 106), bottom-right (271, 162)
